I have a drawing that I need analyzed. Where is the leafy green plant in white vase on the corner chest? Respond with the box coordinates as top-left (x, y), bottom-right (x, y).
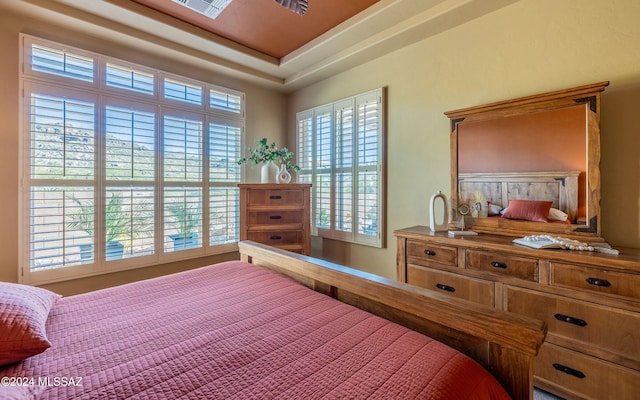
top-left (238, 138), bottom-right (300, 183)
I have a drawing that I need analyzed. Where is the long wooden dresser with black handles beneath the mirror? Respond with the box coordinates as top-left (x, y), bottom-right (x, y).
top-left (394, 226), bottom-right (640, 400)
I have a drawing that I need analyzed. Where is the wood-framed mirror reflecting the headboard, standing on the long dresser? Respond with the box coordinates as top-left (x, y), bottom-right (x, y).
top-left (445, 82), bottom-right (609, 240)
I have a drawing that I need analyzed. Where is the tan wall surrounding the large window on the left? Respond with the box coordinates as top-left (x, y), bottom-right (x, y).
top-left (0, 5), bottom-right (287, 295)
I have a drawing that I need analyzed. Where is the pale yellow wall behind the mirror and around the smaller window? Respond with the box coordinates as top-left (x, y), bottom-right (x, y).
top-left (288, 0), bottom-right (640, 277)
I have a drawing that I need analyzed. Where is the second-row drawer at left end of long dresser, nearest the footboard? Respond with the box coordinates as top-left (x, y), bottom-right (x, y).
top-left (407, 264), bottom-right (495, 307)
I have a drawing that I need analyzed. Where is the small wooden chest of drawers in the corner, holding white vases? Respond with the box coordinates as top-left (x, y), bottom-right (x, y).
top-left (238, 184), bottom-right (311, 255)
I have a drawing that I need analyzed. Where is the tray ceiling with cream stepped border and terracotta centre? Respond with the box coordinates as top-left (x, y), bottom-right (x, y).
top-left (5, 0), bottom-right (519, 92)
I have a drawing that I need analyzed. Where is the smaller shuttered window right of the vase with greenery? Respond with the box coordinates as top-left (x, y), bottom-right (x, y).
top-left (296, 89), bottom-right (385, 247)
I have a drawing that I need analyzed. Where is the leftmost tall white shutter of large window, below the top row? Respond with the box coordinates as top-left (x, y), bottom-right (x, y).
top-left (23, 84), bottom-right (97, 271)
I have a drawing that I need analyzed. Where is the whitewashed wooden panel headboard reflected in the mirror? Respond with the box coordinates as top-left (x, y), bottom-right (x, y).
top-left (458, 171), bottom-right (580, 223)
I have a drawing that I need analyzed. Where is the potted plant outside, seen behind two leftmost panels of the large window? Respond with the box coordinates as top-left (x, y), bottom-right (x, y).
top-left (67, 194), bottom-right (131, 262)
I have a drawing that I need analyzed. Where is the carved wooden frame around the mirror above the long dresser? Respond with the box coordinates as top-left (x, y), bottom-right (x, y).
top-left (445, 81), bottom-right (609, 241)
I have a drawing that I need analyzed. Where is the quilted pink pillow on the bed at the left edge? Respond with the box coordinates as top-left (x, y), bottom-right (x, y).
top-left (0, 282), bottom-right (62, 366)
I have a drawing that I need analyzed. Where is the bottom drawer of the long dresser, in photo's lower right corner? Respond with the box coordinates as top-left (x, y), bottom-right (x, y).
top-left (533, 343), bottom-right (640, 400)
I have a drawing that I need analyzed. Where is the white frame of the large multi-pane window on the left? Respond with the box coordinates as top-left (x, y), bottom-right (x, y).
top-left (19, 34), bottom-right (245, 284)
